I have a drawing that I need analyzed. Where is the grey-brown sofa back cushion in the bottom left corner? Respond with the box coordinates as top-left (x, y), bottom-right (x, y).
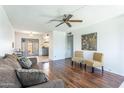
top-left (0, 64), bottom-right (21, 88)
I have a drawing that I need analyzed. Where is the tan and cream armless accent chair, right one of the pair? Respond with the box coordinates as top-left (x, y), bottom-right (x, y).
top-left (84, 52), bottom-right (104, 73)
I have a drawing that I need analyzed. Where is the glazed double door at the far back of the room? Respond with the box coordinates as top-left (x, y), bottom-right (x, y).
top-left (21, 38), bottom-right (39, 56)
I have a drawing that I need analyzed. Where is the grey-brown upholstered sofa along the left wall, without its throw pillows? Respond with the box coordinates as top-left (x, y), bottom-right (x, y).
top-left (0, 54), bottom-right (64, 88)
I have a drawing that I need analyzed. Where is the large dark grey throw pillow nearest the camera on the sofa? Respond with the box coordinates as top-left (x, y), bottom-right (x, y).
top-left (16, 69), bottom-right (48, 87)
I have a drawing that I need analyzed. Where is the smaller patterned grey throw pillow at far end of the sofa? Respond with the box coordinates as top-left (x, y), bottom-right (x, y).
top-left (19, 57), bottom-right (32, 69)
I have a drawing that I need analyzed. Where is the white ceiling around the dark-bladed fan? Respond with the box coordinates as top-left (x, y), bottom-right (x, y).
top-left (3, 5), bottom-right (124, 32)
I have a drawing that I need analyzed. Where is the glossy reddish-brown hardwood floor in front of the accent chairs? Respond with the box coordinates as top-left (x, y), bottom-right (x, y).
top-left (39, 59), bottom-right (124, 88)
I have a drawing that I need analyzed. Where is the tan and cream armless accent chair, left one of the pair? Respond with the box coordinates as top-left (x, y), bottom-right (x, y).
top-left (72, 51), bottom-right (84, 66)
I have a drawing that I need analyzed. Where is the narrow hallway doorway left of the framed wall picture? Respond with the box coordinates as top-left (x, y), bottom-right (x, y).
top-left (66, 33), bottom-right (73, 58)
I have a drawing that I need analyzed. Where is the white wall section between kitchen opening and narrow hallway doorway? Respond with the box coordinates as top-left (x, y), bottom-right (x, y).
top-left (49, 31), bottom-right (66, 60)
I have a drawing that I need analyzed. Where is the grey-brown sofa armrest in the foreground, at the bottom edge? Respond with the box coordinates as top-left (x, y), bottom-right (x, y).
top-left (27, 79), bottom-right (64, 88)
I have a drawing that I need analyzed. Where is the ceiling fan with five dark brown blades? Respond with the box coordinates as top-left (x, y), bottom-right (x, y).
top-left (50, 14), bottom-right (83, 27)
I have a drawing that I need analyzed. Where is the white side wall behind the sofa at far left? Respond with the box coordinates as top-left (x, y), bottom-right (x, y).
top-left (0, 6), bottom-right (14, 56)
